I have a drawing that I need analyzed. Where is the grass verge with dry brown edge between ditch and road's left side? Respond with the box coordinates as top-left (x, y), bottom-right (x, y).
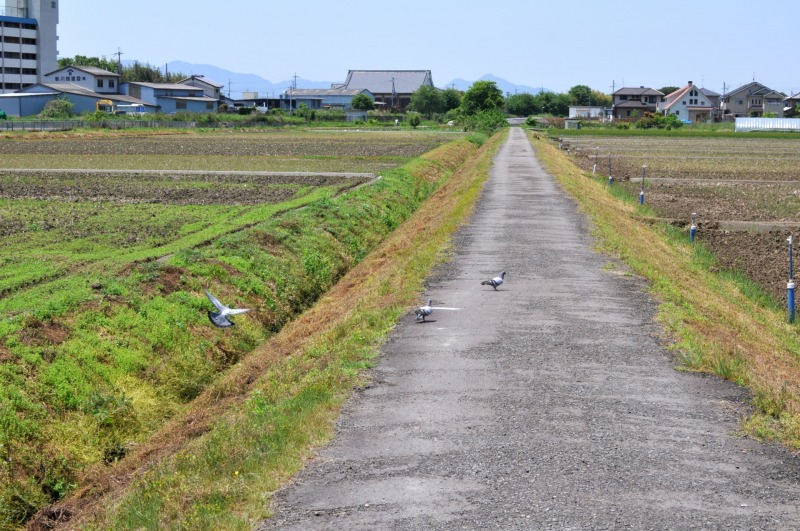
top-left (40, 130), bottom-right (504, 529)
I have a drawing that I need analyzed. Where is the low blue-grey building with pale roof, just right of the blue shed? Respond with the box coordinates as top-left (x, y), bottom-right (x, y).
top-left (120, 81), bottom-right (219, 114)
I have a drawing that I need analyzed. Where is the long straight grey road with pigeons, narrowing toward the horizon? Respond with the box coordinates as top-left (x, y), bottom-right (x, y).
top-left (261, 128), bottom-right (800, 530)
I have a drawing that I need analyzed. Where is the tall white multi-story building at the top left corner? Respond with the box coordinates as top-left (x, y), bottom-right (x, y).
top-left (0, 0), bottom-right (58, 94)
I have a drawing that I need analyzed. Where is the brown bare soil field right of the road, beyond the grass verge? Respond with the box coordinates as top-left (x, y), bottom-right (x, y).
top-left (562, 136), bottom-right (800, 302)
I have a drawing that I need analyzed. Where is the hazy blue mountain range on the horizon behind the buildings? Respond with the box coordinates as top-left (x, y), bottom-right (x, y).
top-left (123, 60), bottom-right (550, 99)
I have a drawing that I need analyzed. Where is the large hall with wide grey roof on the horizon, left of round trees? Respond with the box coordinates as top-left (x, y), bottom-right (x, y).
top-left (331, 70), bottom-right (433, 111)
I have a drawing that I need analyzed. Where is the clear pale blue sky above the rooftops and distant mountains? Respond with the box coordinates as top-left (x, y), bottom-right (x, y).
top-left (58, 0), bottom-right (800, 93)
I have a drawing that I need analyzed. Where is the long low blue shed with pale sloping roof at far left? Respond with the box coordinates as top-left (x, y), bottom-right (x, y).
top-left (0, 83), bottom-right (156, 117)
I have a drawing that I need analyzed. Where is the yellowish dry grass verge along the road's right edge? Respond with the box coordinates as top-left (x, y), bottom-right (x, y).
top-left (534, 135), bottom-right (800, 449)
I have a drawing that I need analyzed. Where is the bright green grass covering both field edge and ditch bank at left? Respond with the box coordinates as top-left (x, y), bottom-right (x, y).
top-left (0, 131), bottom-right (474, 524)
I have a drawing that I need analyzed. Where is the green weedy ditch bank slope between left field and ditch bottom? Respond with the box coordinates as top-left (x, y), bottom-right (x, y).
top-left (0, 132), bottom-right (477, 528)
